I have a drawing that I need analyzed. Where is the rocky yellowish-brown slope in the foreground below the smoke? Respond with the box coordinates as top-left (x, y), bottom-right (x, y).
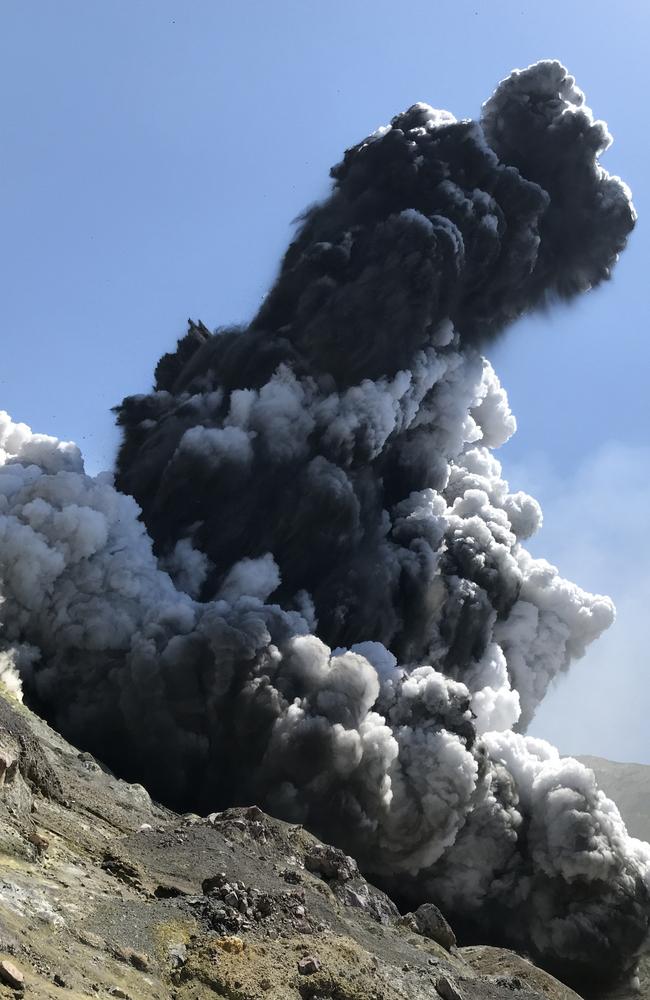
top-left (0, 692), bottom-right (624, 1000)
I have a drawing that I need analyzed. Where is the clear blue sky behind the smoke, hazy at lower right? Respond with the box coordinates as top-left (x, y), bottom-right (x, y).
top-left (0, 0), bottom-right (650, 763)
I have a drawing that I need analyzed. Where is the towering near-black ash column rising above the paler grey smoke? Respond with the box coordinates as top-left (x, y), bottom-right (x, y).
top-left (118, 62), bottom-right (634, 677)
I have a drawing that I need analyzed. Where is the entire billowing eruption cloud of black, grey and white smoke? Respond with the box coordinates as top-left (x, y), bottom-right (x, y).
top-left (0, 62), bottom-right (650, 985)
